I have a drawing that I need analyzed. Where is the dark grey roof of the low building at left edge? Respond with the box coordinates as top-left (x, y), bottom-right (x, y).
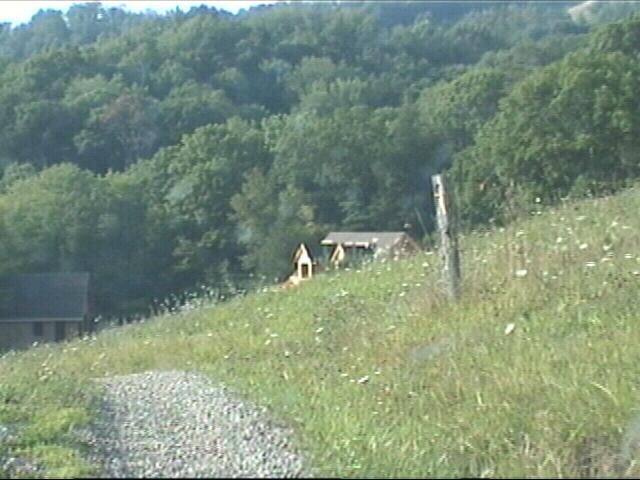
top-left (0, 272), bottom-right (89, 320)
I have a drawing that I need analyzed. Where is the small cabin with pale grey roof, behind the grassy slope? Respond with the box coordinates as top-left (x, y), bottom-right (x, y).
top-left (320, 232), bottom-right (420, 268)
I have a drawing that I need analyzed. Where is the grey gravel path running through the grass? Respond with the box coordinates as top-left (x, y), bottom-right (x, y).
top-left (87, 371), bottom-right (309, 478)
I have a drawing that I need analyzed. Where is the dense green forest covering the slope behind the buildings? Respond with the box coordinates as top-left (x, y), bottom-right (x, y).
top-left (0, 2), bottom-right (640, 314)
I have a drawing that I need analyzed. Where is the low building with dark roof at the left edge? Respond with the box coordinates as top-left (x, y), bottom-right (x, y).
top-left (0, 272), bottom-right (91, 351)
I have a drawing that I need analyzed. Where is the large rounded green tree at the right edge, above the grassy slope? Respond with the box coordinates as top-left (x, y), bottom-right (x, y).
top-left (453, 52), bottom-right (640, 225)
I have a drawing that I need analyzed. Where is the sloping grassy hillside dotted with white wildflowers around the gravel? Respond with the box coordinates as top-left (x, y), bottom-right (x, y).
top-left (0, 188), bottom-right (640, 478)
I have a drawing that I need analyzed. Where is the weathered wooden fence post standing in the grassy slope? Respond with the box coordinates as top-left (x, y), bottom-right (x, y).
top-left (431, 174), bottom-right (460, 299)
